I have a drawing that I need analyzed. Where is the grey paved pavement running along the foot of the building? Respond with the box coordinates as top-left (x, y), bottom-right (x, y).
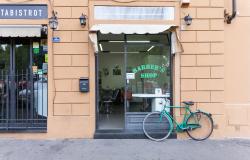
top-left (0, 139), bottom-right (250, 160)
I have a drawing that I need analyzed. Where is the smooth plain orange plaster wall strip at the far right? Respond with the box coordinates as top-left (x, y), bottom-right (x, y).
top-left (225, 0), bottom-right (250, 137)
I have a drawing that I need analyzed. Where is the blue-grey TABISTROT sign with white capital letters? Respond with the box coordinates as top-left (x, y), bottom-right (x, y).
top-left (0, 5), bottom-right (48, 19)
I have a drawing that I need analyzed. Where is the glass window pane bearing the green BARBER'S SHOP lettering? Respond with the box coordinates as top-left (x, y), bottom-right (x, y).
top-left (126, 35), bottom-right (171, 112)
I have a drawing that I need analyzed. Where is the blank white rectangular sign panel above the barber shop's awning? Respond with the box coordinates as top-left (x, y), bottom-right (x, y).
top-left (94, 6), bottom-right (175, 20)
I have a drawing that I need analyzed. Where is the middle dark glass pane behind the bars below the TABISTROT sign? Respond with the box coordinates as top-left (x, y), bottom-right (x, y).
top-left (14, 39), bottom-right (33, 119)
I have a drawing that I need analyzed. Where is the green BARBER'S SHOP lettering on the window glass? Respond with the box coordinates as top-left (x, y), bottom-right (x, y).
top-left (132, 64), bottom-right (166, 79)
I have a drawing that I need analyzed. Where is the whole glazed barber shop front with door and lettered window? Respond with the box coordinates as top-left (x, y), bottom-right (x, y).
top-left (93, 25), bottom-right (181, 138)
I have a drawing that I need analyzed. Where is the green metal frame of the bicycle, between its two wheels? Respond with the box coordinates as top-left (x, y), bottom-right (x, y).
top-left (161, 106), bottom-right (200, 132)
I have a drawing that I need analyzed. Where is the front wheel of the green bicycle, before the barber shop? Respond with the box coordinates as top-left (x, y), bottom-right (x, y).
top-left (143, 112), bottom-right (173, 141)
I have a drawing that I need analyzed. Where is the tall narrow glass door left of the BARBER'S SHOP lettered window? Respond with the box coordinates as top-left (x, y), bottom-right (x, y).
top-left (97, 34), bottom-right (125, 130)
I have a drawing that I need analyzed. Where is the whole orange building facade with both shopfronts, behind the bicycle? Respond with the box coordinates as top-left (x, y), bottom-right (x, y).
top-left (0, 0), bottom-right (250, 139)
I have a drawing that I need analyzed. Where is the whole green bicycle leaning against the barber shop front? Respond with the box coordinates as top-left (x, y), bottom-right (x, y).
top-left (143, 101), bottom-right (213, 141)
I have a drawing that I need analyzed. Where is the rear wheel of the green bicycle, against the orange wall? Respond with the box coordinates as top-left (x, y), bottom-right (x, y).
top-left (186, 112), bottom-right (214, 141)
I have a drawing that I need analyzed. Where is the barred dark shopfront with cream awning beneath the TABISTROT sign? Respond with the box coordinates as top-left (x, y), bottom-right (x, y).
top-left (0, 26), bottom-right (48, 131)
